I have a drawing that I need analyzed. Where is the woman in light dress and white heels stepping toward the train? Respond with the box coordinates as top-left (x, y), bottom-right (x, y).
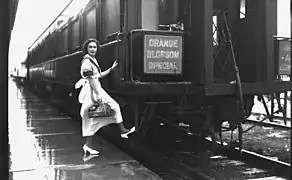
top-left (75, 39), bottom-right (135, 154)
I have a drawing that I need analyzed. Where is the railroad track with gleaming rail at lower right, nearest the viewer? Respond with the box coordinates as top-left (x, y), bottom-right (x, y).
top-left (159, 119), bottom-right (291, 179)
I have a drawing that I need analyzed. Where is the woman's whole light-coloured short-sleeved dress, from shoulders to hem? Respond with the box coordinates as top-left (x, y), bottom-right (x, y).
top-left (75, 54), bottom-right (123, 137)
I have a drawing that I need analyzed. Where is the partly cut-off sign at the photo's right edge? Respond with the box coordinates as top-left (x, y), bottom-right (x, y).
top-left (278, 40), bottom-right (291, 75)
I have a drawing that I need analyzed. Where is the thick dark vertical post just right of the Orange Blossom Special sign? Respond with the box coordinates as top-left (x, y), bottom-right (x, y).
top-left (191, 0), bottom-right (214, 88)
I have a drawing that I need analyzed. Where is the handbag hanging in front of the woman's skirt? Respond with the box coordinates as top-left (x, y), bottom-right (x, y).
top-left (88, 99), bottom-right (113, 118)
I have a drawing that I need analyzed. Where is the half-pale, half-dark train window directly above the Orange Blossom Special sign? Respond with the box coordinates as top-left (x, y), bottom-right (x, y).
top-left (141, 0), bottom-right (179, 30)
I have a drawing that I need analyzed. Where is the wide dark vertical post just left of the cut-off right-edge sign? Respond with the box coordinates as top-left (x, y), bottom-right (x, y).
top-left (246, 0), bottom-right (277, 82)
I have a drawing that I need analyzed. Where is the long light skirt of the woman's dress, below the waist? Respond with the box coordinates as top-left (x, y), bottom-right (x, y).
top-left (79, 79), bottom-right (123, 137)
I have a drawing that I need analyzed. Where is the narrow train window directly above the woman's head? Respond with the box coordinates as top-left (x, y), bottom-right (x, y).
top-left (85, 9), bottom-right (96, 39)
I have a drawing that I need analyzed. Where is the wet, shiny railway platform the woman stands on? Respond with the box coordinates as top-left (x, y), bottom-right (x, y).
top-left (8, 80), bottom-right (161, 180)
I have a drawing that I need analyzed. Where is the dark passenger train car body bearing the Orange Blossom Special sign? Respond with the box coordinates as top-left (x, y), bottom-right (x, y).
top-left (27, 0), bottom-right (291, 146)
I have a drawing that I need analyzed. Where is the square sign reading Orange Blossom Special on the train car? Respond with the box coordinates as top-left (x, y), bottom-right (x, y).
top-left (144, 35), bottom-right (182, 74)
